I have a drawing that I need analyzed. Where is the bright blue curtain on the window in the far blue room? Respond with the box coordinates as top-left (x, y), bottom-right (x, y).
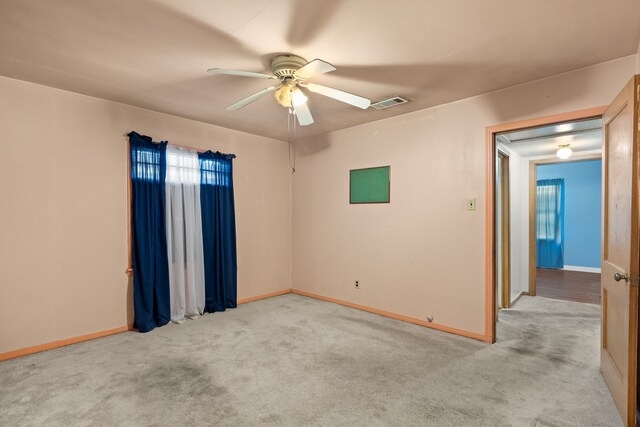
top-left (536, 179), bottom-right (564, 268)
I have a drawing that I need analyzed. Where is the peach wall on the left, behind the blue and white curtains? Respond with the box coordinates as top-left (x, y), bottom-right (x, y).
top-left (0, 77), bottom-right (291, 353)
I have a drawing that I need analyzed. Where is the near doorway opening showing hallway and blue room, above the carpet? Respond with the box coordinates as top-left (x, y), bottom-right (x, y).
top-left (494, 116), bottom-right (602, 320)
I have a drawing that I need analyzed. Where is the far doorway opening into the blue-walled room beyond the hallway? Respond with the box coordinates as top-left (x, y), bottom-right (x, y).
top-left (529, 156), bottom-right (602, 304)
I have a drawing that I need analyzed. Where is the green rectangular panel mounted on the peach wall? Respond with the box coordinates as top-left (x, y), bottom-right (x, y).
top-left (349, 166), bottom-right (390, 203)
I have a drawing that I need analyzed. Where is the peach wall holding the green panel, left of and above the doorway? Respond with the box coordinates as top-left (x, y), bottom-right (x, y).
top-left (292, 55), bottom-right (636, 334)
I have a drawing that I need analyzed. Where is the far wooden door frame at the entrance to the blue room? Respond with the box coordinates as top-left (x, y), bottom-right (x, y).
top-left (527, 153), bottom-right (604, 296)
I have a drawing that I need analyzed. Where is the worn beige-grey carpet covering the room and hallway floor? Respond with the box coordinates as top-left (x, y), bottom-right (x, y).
top-left (0, 295), bottom-right (622, 427)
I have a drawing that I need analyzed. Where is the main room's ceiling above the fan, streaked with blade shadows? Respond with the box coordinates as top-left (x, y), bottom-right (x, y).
top-left (0, 0), bottom-right (640, 140)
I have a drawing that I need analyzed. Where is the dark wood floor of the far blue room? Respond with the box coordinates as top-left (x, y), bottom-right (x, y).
top-left (536, 268), bottom-right (600, 304)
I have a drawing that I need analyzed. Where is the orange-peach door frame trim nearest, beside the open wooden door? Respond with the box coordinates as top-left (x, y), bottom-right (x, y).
top-left (484, 106), bottom-right (607, 343)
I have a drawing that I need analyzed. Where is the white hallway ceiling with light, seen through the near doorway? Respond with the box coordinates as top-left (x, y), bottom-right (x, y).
top-left (496, 118), bottom-right (602, 158)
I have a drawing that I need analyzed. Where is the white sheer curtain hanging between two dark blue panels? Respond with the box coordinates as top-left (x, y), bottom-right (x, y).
top-left (165, 145), bottom-right (204, 323)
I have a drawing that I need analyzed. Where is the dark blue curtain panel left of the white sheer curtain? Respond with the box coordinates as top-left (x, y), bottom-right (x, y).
top-left (129, 132), bottom-right (171, 332)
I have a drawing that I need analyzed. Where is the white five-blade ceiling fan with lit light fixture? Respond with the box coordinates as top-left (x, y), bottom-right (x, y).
top-left (207, 55), bottom-right (371, 126)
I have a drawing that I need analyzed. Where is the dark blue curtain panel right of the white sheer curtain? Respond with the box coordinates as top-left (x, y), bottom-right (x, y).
top-left (198, 151), bottom-right (238, 312)
